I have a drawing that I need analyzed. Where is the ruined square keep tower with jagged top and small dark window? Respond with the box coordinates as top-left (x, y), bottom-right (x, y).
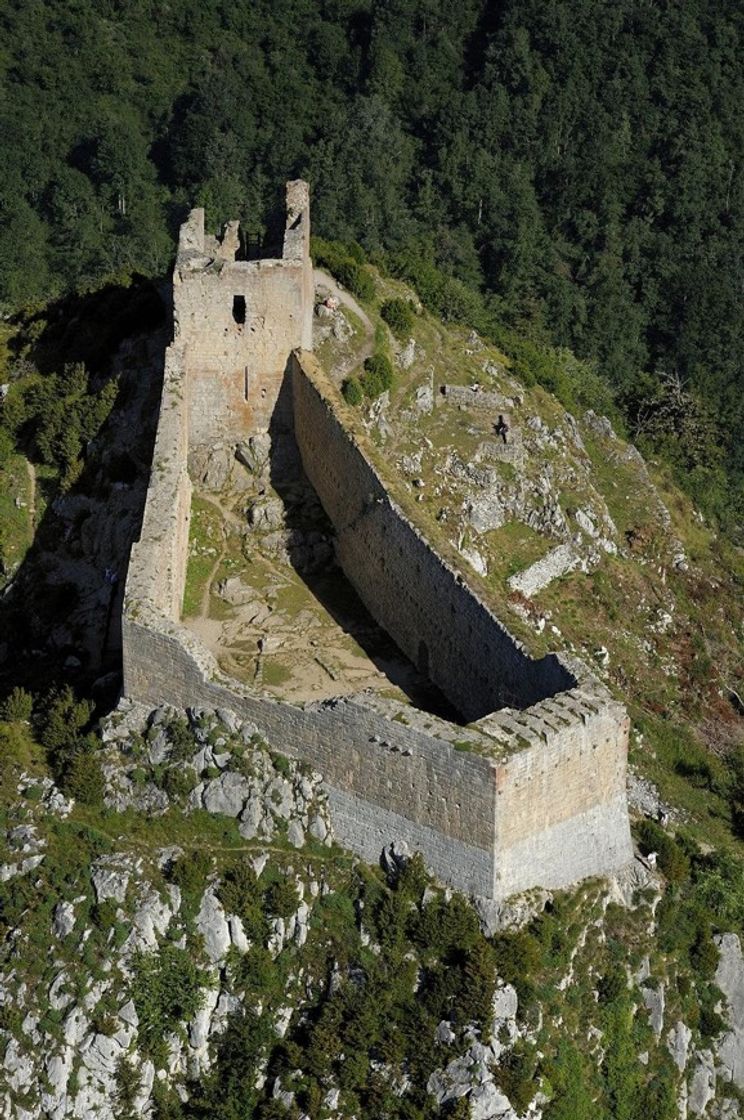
top-left (174, 179), bottom-right (313, 450)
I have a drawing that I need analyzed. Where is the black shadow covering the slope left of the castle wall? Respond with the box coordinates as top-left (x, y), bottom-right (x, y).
top-left (0, 278), bottom-right (170, 712)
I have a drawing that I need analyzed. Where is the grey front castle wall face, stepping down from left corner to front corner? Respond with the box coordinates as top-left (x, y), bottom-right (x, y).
top-left (123, 601), bottom-right (496, 896)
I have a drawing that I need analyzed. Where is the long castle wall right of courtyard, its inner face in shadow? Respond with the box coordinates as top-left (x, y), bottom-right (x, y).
top-left (292, 353), bottom-right (576, 721)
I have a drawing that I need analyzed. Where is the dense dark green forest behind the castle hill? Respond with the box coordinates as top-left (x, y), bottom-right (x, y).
top-left (0, 0), bottom-right (744, 530)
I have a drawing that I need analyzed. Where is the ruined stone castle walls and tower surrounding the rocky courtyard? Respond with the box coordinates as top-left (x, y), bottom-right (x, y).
top-left (122, 181), bottom-right (632, 899)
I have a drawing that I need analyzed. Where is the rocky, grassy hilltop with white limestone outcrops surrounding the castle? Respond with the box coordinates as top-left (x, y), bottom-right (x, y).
top-left (0, 254), bottom-right (744, 1120)
